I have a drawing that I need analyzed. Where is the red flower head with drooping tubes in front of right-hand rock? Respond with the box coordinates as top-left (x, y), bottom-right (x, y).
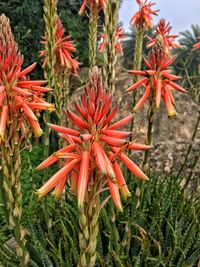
top-left (126, 45), bottom-right (187, 117)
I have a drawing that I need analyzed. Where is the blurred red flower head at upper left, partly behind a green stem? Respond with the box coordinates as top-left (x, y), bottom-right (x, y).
top-left (40, 18), bottom-right (80, 75)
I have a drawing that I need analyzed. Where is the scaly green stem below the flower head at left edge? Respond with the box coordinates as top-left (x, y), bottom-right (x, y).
top-left (1, 129), bottom-right (29, 267)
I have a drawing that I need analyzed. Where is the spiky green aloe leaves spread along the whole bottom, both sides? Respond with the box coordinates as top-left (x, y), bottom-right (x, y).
top-left (0, 146), bottom-right (200, 267)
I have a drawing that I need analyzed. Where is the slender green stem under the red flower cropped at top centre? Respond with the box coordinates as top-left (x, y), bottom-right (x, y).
top-left (89, 9), bottom-right (98, 69)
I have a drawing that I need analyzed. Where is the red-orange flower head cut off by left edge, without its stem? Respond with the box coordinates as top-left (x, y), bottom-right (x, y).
top-left (0, 15), bottom-right (54, 141)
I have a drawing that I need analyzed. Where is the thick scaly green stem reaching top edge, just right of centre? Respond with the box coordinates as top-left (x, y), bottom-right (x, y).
top-left (103, 0), bottom-right (119, 95)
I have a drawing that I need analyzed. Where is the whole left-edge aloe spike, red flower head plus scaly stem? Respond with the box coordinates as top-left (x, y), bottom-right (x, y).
top-left (0, 15), bottom-right (54, 267)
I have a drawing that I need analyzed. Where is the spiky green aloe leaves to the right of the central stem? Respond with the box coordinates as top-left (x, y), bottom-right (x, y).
top-left (99, 177), bottom-right (200, 267)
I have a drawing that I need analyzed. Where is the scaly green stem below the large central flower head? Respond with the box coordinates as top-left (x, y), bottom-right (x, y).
top-left (78, 177), bottom-right (100, 267)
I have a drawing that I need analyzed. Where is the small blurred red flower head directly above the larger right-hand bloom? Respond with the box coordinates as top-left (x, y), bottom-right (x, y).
top-left (147, 19), bottom-right (181, 55)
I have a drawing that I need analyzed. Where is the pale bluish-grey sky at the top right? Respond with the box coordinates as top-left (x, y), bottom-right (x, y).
top-left (119, 0), bottom-right (200, 34)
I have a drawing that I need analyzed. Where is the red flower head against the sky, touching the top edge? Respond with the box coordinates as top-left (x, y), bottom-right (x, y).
top-left (130, 0), bottom-right (159, 30)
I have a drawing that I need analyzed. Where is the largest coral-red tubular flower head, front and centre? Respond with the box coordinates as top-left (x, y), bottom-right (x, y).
top-left (38, 68), bottom-right (151, 210)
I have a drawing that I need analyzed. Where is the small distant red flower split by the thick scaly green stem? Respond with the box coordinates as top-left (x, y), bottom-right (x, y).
top-left (99, 27), bottom-right (126, 56)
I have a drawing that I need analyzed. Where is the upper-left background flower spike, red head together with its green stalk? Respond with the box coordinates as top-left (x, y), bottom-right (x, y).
top-left (40, 16), bottom-right (79, 131)
